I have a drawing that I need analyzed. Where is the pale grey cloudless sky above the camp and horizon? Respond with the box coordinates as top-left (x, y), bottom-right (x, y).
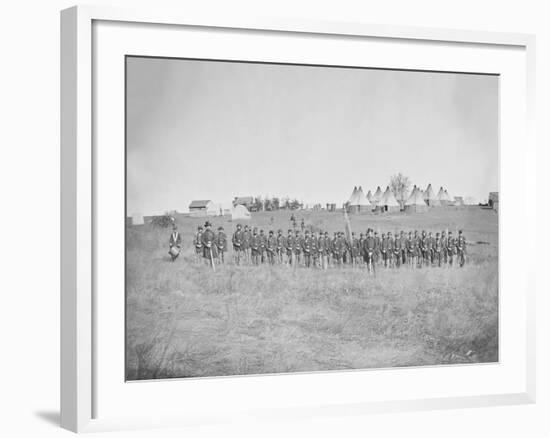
top-left (126, 57), bottom-right (499, 215)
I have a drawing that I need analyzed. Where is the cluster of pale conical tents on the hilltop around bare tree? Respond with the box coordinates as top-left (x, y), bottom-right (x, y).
top-left (346, 184), bottom-right (463, 213)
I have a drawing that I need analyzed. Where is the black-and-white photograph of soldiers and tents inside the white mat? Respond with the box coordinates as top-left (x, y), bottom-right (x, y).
top-left (124, 56), bottom-right (499, 380)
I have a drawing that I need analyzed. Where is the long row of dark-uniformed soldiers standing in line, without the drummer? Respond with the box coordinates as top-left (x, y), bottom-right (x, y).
top-left (171, 222), bottom-right (466, 271)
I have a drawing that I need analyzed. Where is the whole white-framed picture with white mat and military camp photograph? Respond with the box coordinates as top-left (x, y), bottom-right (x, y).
top-left (61, 7), bottom-right (536, 431)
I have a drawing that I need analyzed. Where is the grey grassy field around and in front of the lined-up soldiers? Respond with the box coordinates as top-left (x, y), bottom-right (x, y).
top-left (126, 207), bottom-right (498, 380)
